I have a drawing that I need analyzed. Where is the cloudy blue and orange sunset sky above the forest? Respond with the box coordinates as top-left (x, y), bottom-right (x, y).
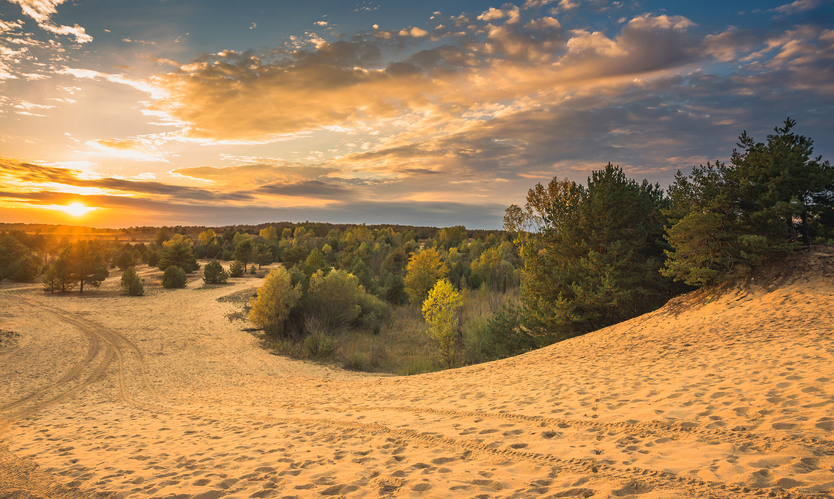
top-left (0, 0), bottom-right (834, 229)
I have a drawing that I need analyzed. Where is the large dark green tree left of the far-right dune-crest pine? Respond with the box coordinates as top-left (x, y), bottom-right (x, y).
top-left (505, 163), bottom-right (675, 344)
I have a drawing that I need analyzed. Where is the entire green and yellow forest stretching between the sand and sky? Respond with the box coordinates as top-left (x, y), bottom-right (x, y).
top-left (0, 118), bottom-right (834, 374)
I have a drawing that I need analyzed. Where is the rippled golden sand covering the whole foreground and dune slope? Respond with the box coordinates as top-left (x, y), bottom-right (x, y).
top-left (0, 252), bottom-right (834, 499)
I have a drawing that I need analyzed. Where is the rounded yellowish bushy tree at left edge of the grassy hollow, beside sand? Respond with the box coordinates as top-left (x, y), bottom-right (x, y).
top-left (249, 267), bottom-right (302, 336)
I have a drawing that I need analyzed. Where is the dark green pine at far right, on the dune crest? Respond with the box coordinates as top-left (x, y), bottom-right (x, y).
top-left (662, 118), bottom-right (834, 286)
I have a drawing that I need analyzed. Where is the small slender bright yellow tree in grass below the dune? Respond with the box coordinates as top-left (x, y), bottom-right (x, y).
top-left (423, 279), bottom-right (463, 367)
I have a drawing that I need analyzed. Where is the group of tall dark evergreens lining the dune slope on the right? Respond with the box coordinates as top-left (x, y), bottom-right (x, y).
top-left (500, 119), bottom-right (834, 348)
